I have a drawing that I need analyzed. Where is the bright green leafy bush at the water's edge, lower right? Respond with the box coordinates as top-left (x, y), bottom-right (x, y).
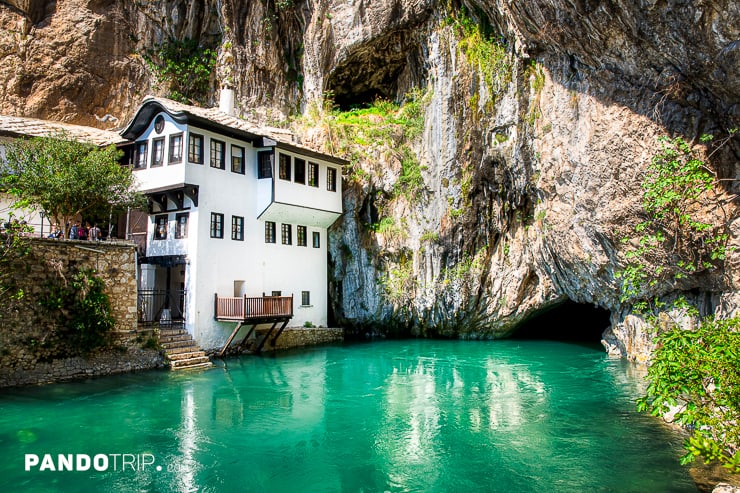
top-left (638, 318), bottom-right (740, 473)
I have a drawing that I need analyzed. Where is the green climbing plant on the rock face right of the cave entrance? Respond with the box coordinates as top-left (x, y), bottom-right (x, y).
top-left (618, 136), bottom-right (729, 302)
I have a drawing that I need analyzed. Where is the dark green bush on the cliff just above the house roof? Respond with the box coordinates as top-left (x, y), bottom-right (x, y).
top-left (142, 38), bottom-right (217, 103)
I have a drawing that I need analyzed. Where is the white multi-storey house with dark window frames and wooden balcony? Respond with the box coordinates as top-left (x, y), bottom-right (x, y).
top-left (121, 97), bottom-right (346, 349)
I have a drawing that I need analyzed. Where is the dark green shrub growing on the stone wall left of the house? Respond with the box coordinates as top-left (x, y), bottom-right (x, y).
top-left (40, 269), bottom-right (115, 353)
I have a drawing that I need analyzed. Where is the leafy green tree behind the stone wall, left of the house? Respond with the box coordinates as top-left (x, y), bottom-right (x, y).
top-left (0, 134), bottom-right (143, 233)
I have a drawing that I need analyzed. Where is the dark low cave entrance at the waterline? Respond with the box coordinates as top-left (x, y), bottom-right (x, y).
top-left (511, 300), bottom-right (611, 343)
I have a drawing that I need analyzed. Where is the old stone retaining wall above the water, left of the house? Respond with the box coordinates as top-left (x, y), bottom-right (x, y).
top-left (0, 238), bottom-right (164, 387)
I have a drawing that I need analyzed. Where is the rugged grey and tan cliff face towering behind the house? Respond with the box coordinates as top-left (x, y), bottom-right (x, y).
top-left (0, 0), bottom-right (740, 359)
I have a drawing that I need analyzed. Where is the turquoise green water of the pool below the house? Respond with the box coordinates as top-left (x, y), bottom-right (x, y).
top-left (0, 341), bottom-right (695, 493)
